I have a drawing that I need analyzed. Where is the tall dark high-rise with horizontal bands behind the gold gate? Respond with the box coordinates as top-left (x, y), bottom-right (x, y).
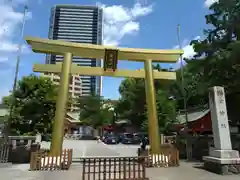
top-left (46, 5), bottom-right (103, 96)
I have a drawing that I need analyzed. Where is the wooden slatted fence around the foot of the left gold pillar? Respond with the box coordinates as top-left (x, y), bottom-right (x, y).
top-left (30, 149), bottom-right (72, 171)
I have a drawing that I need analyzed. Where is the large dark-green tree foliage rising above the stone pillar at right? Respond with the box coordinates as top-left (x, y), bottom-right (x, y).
top-left (171, 0), bottom-right (240, 111)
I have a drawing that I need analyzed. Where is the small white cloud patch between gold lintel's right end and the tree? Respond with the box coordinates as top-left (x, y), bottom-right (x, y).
top-left (173, 36), bottom-right (200, 69)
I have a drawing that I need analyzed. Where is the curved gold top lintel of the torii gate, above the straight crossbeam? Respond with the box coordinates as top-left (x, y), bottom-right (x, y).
top-left (25, 37), bottom-right (183, 63)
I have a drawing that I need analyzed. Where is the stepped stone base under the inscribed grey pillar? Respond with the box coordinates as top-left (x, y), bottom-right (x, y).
top-left (203, 150), bottom-right (240, 175)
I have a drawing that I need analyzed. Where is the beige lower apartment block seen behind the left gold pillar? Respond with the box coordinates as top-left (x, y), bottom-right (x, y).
top-left (40, 73), bottom-right (82, 111)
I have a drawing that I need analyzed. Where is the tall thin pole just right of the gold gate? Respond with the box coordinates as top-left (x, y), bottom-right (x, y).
top-left (177, 24), bottom-right (191, 160)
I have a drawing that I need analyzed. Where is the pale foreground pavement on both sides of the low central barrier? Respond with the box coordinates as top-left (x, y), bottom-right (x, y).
top-left (0, 162), bottom-right (240, 180)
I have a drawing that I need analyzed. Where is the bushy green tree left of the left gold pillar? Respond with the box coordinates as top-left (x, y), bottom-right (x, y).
top-left (3, 75), bottom-right (57, 135)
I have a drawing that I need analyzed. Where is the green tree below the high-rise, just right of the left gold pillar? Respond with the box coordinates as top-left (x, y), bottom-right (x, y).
top-left (77, 94), bottom-right (113, 128)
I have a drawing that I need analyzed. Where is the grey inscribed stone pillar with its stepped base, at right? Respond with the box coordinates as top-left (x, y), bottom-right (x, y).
top-left (203, 87), bottom-right (240, 175)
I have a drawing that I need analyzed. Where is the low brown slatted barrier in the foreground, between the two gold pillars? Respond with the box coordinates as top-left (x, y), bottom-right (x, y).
top-left (82, 157), bottom-right (148, 180)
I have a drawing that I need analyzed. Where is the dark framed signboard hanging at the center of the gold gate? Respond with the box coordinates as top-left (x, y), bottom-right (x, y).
top-left (103, 49), bottom-right (118, 71)
